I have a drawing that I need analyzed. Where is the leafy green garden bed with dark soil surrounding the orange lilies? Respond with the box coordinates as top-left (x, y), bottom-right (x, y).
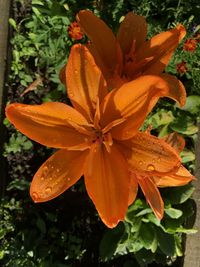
top-left (0, 0), bottom-right (200, 267)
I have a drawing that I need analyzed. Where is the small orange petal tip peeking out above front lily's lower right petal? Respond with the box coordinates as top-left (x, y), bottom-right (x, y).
top-left (162, 132), bottom-right (185, 153)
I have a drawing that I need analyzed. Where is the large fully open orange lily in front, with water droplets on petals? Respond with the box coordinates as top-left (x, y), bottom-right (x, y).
top-left (6, 44), bottom-right (186, 227)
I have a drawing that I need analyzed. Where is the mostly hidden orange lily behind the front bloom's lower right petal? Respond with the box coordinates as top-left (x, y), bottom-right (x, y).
top-left (124, 133), bottom-right (195, 220)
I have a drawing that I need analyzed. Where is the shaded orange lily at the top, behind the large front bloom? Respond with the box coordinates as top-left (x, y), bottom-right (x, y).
top-left (77, 10), bottom-right (186, 88)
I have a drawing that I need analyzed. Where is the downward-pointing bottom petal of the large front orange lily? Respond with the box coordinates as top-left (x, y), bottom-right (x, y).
top-left (84, 143), bottom-right (130, 228)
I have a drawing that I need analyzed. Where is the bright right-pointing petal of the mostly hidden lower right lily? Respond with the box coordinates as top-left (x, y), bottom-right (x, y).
top-left (153, 165), bottom-right (195, 187)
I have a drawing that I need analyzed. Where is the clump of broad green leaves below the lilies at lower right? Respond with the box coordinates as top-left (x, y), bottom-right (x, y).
top-left (100, 184), bottom-right (196, 266)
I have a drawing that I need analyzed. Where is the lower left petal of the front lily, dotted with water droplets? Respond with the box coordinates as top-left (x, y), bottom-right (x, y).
top-left (30, 149), bottom-right (88, 202)
